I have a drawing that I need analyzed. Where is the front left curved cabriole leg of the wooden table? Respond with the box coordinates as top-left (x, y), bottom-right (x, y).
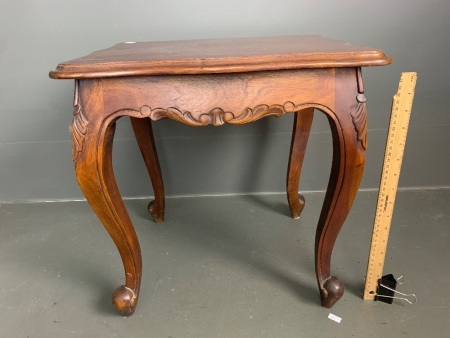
top-left (72, 94), bottom-right (142, 316)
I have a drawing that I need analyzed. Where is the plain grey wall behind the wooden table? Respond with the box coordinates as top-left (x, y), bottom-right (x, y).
top-left (0, 0), bottom-right (450, 201)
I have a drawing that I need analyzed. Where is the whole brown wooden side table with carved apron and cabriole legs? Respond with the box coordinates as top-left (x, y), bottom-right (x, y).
top-left (50, 36), bottom-right (391, 316)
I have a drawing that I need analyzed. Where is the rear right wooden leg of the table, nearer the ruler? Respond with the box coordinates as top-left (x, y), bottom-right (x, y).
top-left (286, 108), bottom-right (314, 219)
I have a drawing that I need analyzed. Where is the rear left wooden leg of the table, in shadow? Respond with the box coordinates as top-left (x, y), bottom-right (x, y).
top-left (131, 117), bottom-right (165, 223)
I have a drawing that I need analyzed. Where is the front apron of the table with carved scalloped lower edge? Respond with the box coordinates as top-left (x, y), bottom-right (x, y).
top-left (98, 69), bottom-right (335, 126)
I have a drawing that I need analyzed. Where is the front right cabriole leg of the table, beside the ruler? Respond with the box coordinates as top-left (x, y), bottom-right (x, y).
top-left (315, 69), bottom-right (367, 308)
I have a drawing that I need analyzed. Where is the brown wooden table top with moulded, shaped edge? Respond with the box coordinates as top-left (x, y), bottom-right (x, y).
top-left (49, 35), bottom-right (391, 79)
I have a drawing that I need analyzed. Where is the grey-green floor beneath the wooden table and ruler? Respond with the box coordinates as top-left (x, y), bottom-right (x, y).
top-left (0, 189), bottom-right (450, 338)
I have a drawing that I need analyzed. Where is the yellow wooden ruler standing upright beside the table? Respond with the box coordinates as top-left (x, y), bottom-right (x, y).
top-left (364, 72), bottom-right (417, 300)
